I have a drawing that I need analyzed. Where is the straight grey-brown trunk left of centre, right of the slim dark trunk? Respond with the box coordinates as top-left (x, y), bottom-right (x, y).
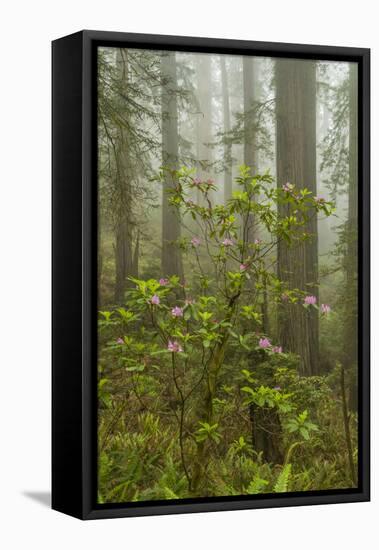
top-left (161, 52), bottom-right (183, 279)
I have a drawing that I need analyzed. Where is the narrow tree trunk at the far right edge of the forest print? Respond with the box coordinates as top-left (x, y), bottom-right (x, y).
top-left (344, 63), bottom-right (358, 409)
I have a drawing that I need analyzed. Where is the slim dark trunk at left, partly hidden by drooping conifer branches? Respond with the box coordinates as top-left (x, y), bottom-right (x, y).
top-left (114, 49), bottom-right (133, 303)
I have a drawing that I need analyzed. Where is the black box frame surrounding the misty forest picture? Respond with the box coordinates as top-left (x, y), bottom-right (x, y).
top-left (52, 30), bottom-right (370, 519)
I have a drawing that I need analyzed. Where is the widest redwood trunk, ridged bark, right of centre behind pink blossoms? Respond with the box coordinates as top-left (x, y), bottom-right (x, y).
top-left (276, 59), bottom-right (319, 375)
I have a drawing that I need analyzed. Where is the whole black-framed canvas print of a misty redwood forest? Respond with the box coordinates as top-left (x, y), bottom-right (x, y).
top-left (52, 31), bottom-right (370, 519)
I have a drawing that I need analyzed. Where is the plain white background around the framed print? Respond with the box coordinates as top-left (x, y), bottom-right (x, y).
top-left (0, 0), bottom-right (379, 550)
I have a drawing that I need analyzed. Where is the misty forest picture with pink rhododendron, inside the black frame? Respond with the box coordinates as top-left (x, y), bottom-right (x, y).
top-left (97, 47), bottom-right (359, 504)
